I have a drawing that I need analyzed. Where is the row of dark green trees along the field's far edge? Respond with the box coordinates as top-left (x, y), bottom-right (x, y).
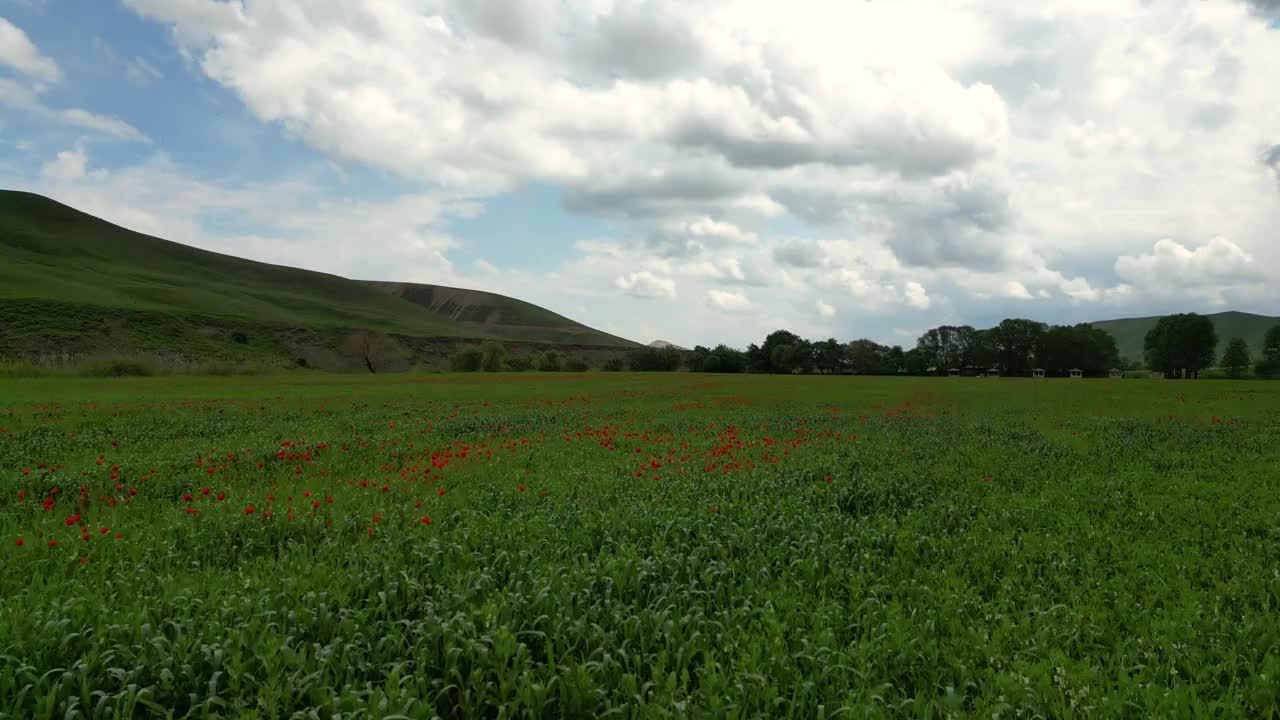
top-left (344, 313), bottom-right (1280, 378)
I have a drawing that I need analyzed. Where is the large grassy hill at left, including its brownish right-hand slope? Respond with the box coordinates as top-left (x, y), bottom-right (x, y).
top-left (0, 191), bottom-right (635, 366)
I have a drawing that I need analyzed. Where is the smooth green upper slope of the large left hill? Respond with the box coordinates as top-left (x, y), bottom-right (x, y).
top-left (0, 191), bottom-right (476, 336)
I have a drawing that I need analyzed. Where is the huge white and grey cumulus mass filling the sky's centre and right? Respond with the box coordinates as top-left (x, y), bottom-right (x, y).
top-left (45, 0), bottom-right (1280, 345)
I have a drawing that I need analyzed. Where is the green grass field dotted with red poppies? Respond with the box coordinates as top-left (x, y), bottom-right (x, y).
top-left (0, 374), bottom-right (1280, 719)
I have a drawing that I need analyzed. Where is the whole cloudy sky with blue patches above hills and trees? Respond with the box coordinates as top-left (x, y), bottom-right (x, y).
top-left (0, 0), bottom-right (1280, 347)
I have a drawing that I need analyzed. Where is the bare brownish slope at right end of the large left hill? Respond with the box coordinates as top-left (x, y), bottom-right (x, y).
top-left (365, 281), bottom-right (636, 347)
